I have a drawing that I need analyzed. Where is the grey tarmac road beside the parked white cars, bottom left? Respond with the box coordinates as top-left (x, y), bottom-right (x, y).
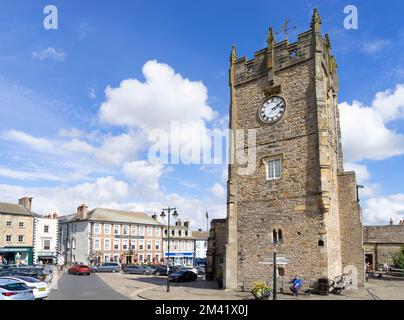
top-left (48, 272), bottom-right (128, 300)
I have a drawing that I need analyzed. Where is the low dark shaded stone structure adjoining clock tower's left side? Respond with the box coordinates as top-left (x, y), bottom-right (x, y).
top-left (206, 219), bottom-right (226, 280)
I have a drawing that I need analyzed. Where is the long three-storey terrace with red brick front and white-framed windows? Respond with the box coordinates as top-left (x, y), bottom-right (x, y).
top-left (59, 204), bottom-right (164, 264)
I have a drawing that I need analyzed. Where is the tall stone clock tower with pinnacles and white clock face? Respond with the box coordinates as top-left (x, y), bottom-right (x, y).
top-left (224, 9), bottom-right (364, 290)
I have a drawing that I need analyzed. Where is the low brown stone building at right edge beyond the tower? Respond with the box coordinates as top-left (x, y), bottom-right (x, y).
top-left (363, 221), bottom-right (404, 268)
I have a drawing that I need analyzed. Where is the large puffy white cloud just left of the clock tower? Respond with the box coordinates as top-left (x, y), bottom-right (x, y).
top-left (99, 60), bottom-right (216, 158)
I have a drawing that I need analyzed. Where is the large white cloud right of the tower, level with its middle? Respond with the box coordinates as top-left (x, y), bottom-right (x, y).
top-left (339, 85), bottom-right (404, 162)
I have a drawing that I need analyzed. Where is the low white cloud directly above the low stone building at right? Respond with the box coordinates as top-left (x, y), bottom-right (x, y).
top-left (363, 194), bottom-right (404, 225)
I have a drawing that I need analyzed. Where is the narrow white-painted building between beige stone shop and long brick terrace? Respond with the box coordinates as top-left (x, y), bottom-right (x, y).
top-left (33, 213), bottom-right (58, 264)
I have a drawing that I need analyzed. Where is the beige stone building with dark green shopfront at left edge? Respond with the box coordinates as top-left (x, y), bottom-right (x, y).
top-left (0, 197), bottom-right (34, 265)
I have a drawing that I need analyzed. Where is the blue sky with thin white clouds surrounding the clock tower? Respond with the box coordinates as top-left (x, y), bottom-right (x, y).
top-left (0, 0), bottom-right (404, 227)
